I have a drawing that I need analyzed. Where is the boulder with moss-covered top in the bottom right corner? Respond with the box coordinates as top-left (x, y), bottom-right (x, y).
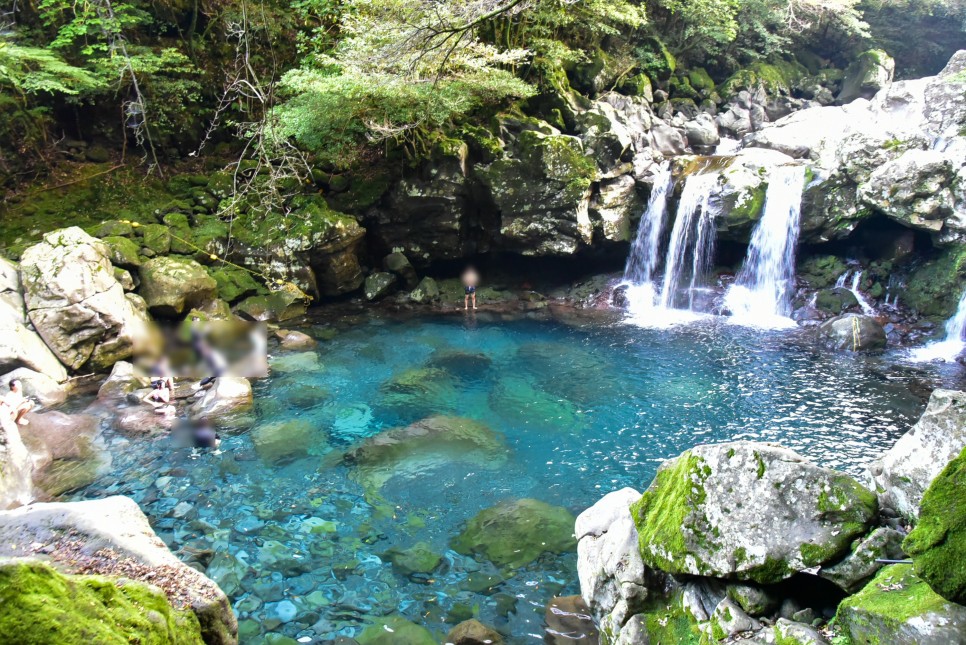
top-left (836, 564), bottom-right (966, 645)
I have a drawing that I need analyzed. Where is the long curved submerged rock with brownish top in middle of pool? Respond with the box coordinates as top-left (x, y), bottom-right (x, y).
top-left (344, 416), bottom-right (506, 489)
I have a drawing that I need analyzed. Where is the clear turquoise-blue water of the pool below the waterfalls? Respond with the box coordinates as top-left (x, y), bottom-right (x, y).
top-left (72, 316), bottom-right (923, 643)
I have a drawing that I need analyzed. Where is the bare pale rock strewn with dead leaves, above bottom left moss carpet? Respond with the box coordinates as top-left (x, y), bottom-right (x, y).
top-left (0, 496), bottom-right (238, 645)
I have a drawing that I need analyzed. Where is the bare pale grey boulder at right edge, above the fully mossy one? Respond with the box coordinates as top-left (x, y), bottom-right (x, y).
top-left (869, 390), bottom-right (966, 519)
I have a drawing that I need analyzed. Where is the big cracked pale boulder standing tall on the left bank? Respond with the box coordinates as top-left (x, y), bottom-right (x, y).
top-left (20, 227), bottom-right (153, 370)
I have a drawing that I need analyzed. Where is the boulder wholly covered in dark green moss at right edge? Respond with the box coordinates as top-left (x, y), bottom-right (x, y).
top-left (902, 450), bottom-right (966, 605)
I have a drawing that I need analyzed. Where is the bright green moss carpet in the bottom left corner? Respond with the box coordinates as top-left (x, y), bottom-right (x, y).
top-left (0, 562), bottom-right (203, 645)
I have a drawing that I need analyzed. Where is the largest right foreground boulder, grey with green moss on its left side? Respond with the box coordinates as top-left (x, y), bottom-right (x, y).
top-left (631, 441), bottom-right (878, 584)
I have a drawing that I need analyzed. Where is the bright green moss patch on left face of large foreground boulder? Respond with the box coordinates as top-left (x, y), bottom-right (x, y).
top-left (631, 451), bottom-right (708, 573)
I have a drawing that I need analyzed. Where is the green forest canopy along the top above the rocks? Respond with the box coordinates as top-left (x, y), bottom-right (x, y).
top-left (0, 0), bottom-right (966, 175)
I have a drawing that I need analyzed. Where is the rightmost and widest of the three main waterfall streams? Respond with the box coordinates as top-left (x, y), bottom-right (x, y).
top-left (725, 166), bottom-right (805, 327)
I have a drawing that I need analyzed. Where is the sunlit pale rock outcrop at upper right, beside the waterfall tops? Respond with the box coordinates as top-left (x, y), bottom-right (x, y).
top-left (744, 50), bottom-right (966, 244)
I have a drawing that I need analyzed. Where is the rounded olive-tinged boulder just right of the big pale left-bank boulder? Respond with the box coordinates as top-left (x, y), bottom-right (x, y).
top-left (138, 256), bottom-right (218, 316)
